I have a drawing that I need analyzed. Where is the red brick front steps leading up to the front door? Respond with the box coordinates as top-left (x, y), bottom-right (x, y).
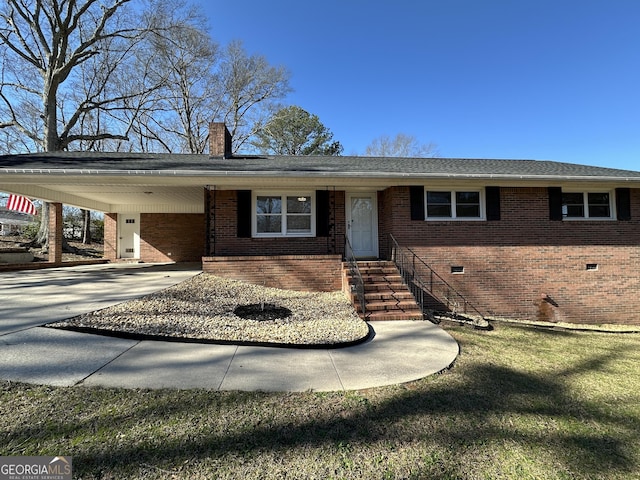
top-left (344, 261), bottom-right (423, 321)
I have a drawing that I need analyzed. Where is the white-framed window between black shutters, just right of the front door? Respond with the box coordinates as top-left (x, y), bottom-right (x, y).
top-left (425, 188), bottom-right (485, 220)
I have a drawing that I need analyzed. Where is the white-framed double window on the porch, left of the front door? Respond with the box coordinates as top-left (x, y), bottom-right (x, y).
top-left (252, 192), bottom-right (316, 237)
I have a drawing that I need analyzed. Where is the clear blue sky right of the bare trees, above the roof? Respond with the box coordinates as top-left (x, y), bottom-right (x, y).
top-left (200, 0), bottom-right (640, 170)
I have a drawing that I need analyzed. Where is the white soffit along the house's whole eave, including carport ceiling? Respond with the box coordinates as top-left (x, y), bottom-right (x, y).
top-left (0, 171), bottom-right (640, 213)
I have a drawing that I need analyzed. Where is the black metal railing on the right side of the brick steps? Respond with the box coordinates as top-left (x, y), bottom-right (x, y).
top-left (389, 235), bottom-right (488, 327)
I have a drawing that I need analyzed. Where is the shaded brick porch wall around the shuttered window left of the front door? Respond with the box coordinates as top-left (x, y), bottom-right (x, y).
top-left (207, 190), bottom-right (346, 256)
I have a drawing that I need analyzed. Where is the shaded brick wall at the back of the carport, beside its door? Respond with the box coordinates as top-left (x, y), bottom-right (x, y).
top-left (140, 213), bottom-right (205, 262)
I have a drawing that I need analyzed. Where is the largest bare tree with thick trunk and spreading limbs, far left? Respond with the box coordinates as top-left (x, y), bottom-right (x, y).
top-left (0, 0), bottom-right (151, 152)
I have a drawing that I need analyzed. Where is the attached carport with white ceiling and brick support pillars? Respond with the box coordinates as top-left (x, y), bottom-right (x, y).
top-left (0, 152), bottom-right (218, 266)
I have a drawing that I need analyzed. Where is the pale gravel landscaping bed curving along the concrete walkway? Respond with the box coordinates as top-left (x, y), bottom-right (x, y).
top-left (48, 273), bottom-right (369, 345)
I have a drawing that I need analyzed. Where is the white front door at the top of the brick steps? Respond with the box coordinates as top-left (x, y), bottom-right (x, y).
top-left (346, 192), bottom-right (378, 258)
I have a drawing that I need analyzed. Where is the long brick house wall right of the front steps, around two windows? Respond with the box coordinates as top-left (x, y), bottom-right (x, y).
top-left (380, 188), bottom-right (640, 324)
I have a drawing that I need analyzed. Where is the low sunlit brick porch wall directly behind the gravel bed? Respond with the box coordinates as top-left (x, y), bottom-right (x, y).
top-left (202, 255), bottom-right (342, 292)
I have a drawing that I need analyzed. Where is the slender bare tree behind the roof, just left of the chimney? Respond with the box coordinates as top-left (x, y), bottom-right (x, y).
top-left (117, 1), bottom-right (218, 153)
